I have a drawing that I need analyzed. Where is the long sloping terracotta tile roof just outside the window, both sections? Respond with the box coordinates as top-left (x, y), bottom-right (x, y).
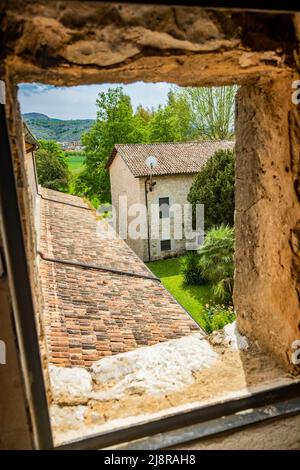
top-left (39, 190), bottom-right (198, 367)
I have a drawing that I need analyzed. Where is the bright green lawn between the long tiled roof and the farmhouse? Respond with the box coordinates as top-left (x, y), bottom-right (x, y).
top-left (147, 258), bottom-right (210, 326)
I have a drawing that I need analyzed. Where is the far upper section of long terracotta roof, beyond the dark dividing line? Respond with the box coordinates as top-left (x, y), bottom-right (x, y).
top-left (40, 189), bottom-right (154, 277)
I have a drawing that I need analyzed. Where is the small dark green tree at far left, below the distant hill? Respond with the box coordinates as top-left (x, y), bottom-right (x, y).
top-left (35, 140), bottom-right (70, 191)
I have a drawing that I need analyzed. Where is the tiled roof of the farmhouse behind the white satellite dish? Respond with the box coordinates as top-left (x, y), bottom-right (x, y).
top-left (107, 140), bottom-right (235, 177)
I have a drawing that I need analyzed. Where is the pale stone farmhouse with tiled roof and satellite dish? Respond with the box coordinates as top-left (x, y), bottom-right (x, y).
top-left (107, 140), bottom-right (234, 261)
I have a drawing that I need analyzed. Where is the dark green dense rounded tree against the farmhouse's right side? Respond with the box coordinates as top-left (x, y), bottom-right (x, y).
top-left (188, 150), bottom-right (235, 230)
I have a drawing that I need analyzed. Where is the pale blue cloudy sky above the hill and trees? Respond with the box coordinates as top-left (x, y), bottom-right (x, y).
top-left (18, 82), bottom-right (170, 119)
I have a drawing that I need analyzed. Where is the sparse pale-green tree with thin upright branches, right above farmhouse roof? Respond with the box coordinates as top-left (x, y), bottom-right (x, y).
top-left (175, 86), bottom-right (237, 140)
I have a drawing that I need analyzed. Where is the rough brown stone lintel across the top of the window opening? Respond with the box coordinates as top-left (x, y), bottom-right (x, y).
top-left (0, 0), bottom-right (299, 85)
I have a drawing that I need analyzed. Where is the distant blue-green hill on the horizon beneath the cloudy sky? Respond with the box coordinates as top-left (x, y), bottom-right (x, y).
top-left (23, 113), bottom-right (94, 142)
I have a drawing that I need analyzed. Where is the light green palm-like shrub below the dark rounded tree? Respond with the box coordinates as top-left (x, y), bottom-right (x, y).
top-left (198, 225), bottom-right (234, 303)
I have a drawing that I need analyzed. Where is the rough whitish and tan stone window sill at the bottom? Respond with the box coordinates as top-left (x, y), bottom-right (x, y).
top-left (46, 322), bottom-right (299, 450)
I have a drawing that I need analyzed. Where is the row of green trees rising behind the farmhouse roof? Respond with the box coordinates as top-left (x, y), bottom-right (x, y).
top-left (74, 87), bottom-right (236, 203)
